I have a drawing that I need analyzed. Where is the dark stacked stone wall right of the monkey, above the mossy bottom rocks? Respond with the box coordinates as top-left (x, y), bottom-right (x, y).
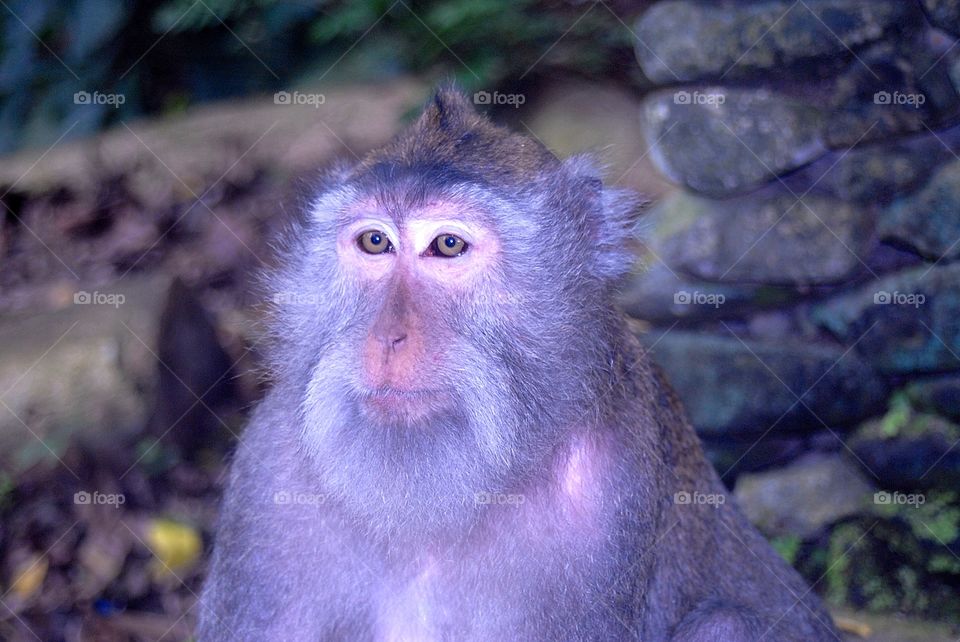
top-left (625, 0), bottom-right (960, 616)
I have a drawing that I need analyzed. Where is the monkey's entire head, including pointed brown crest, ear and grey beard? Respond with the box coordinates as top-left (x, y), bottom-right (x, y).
top-left (275, 93), bottom-right (636, 530)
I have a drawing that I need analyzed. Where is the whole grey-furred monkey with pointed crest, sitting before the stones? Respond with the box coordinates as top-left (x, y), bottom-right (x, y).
top-left (198, 86), bottom-right (840, 642)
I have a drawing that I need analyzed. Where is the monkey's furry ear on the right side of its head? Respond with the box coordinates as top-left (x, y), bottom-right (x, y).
top-left (564, 154), bottom-right (648, 280)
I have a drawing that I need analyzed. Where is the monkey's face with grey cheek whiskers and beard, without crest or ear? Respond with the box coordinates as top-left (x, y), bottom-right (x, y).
top-left (292, 180), bottom-right (595, 524)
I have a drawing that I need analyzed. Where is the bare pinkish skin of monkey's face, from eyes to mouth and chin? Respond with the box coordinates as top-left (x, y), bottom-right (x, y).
top-left (336, 201), bottom-right (500, 426)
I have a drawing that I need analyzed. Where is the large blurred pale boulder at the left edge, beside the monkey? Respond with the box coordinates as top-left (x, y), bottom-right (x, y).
top-left (0, 277), bottom-right (167, 474)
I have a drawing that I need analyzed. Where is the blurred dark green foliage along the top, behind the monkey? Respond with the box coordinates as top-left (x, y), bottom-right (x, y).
top-left (0, 0), bottom-right (639, 151)
